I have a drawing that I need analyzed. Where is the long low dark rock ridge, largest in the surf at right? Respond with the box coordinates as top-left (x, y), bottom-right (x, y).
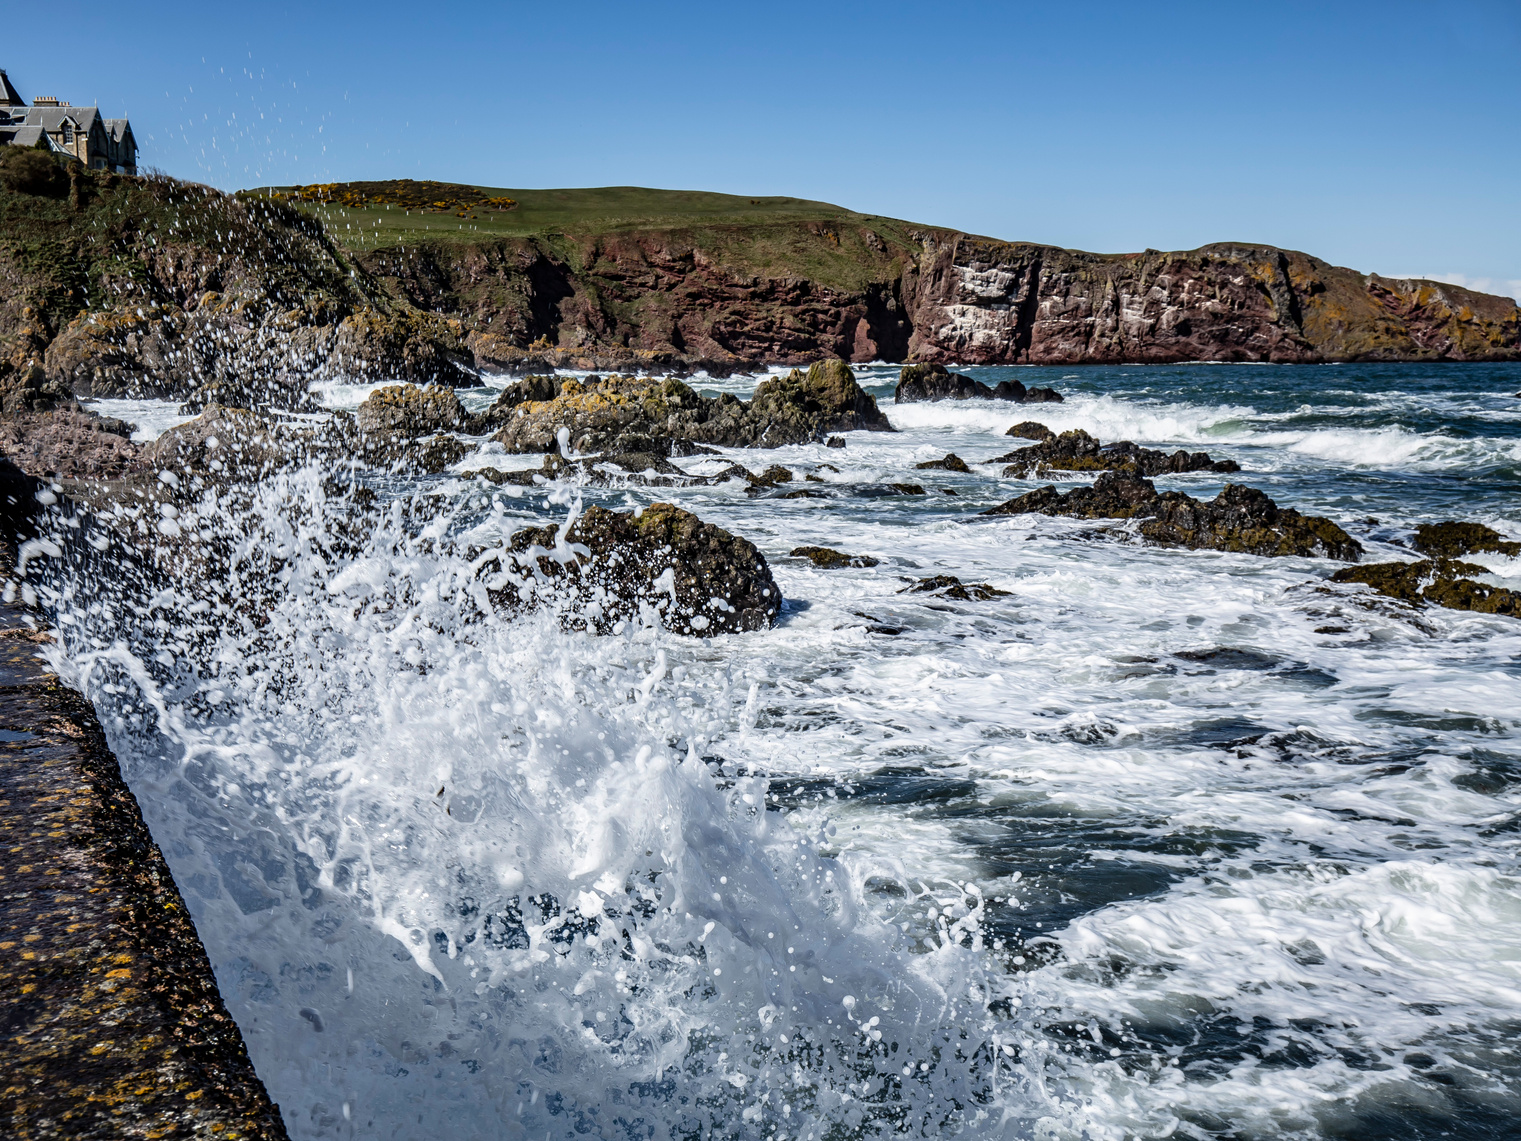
top-left (983, 472), bottom-right (1363, 563)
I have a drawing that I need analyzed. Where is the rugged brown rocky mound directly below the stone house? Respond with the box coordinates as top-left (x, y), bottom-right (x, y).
top-left (0, 170), bottom-right (475, 408)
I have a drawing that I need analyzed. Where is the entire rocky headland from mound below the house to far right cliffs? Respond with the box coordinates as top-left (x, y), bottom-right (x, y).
top-left (0, 170), bottom-right (1521, 406)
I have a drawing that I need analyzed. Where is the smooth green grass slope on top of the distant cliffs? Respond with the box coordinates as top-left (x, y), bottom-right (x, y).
top-left (242, 186), bottom-right (887, 249)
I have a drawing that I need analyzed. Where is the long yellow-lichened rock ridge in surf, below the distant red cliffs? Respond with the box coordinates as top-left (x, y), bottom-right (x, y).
top-left (493, 361), bottom-right (893, 455)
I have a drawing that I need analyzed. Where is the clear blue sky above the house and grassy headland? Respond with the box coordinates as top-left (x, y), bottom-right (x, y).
top-left (0, 0), bottom-right (1521, 295)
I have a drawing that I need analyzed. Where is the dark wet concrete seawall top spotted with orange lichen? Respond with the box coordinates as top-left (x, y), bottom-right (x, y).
top-left (0, 605), bottom-right (286, 1141)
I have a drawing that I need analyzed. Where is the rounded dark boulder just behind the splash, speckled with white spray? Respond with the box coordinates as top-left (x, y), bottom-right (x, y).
top-left (493, 504), bottom-right (782, 637)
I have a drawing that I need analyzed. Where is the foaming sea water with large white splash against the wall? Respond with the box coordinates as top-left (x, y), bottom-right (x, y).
top-left (27, 365), bottom-right (1521, 1141)
